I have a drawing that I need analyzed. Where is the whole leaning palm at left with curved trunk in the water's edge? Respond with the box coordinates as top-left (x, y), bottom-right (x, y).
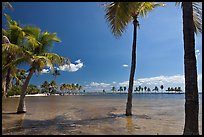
top-left (3, 27), bottom-right (69, 113)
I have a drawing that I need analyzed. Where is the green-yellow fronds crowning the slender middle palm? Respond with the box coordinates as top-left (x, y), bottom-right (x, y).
top-left (104, 2), bottom-right (165, 38)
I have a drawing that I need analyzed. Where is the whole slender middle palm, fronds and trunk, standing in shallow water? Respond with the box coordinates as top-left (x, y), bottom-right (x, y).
top-left (105, 2), bottom-right (164, 116)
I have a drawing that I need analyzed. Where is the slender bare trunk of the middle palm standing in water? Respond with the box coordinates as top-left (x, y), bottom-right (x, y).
top-left (126, 18), bottom-right (138, 116)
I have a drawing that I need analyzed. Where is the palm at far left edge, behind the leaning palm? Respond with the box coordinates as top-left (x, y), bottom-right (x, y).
top-left (2, 14), bottom-right (36, 97)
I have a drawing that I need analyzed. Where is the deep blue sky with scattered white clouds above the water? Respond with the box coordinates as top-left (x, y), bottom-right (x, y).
top-left (2, 2), bottom-right (202, 91)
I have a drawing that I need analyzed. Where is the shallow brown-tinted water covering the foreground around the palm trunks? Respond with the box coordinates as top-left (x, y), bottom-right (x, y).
top-left (2, 94), bottom-right (202, 135)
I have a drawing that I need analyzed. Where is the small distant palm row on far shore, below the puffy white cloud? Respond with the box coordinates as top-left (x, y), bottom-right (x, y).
top-left (60, 83), bottom-right (82, 92)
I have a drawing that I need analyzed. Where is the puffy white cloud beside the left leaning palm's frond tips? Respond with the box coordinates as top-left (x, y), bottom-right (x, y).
top-left (59, 59), bottom-right (84, 72)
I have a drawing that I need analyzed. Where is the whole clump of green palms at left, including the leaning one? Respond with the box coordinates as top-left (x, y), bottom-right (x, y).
top-left (2, 11), bottom-right (69, 113)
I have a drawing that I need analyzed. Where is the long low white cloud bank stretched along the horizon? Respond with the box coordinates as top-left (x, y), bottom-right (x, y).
top-left (85, 74), bottom-right (202, 92)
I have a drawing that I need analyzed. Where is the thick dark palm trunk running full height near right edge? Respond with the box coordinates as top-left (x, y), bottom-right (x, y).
top-left (182, 2), bottom-right (199, 135)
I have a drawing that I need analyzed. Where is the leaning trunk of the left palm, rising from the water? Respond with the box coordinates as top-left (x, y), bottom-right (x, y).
top-left (17, 68), bottom-right (35, 114)
